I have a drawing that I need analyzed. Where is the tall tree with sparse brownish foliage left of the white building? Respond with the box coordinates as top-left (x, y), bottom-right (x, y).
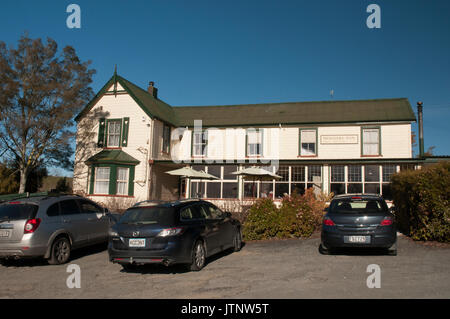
top-left (0, 35), bottom-right (95, 193)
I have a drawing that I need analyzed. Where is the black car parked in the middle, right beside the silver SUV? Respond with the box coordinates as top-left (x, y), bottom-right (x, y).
top-left (108, 200), bottom-right (242, 271)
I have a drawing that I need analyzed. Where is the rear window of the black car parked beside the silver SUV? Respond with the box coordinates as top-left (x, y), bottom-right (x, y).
top-left (119, 206), bottom-right (175, 226)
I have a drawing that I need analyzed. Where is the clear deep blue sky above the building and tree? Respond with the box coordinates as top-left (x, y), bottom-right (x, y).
top-left (0, 0), bottom-right (450, 176)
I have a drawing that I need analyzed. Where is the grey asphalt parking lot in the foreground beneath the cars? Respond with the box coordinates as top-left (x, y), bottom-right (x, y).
top-left (0, 236), bottom-right (450, 299)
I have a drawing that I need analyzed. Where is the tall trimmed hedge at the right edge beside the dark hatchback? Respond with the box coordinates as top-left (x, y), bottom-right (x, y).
top-left (391, 162), bottom-right (450, 242)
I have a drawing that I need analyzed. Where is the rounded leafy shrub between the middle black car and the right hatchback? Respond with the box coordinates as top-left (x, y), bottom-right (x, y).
top-left (243, 189), bottom-right (328, 240)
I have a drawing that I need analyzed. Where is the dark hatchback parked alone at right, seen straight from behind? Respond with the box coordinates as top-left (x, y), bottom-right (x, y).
top-left (319, 194), bottom-right (397, 255)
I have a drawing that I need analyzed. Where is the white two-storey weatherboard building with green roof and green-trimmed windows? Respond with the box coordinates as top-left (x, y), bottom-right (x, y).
top-left (74, 74), bottom-right (421, 208)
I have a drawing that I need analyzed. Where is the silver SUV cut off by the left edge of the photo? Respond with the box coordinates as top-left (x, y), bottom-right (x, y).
top-left (0, 195), bottom-right (112, 265)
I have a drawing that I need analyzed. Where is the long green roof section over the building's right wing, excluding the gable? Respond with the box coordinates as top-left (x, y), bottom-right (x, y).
top-left (174, 98), bottom-right (416, 127)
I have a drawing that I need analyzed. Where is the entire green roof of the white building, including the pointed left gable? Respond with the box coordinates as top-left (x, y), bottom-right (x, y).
top-left (75, 74), bottom-right (416, 127)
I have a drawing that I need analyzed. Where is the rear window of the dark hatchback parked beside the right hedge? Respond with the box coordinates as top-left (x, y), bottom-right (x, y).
top-left (329, 198), bottom-right (389, 214)
